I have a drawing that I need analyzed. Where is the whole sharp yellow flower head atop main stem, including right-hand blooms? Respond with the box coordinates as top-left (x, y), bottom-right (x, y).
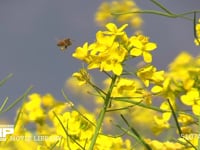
top-left (72, 23), bottom-right (157, 76)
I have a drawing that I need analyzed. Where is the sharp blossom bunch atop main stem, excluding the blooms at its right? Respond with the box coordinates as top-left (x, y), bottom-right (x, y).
top-left (72, 23), bottom-right (128, 75)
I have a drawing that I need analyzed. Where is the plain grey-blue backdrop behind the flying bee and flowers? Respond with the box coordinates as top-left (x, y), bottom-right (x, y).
top-left (0, 0), bottom-right (200, 121)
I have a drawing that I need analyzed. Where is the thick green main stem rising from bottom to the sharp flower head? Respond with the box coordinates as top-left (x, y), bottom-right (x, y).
top-left (89, 75), bottom-right (117, 150)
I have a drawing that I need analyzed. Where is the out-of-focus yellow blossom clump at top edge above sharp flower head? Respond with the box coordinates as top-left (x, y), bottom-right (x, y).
top-left (95, 0), bottom-right (143, 28)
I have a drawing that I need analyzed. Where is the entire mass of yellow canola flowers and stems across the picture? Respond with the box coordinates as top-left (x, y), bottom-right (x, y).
top-left (0, 0), bottom-right (200, 150)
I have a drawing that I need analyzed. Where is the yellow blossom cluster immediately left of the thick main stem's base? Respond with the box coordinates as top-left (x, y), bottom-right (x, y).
top-left (50, 110), bottom-right (95, 149)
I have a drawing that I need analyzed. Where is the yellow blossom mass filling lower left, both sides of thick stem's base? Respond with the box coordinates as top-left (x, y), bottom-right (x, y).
top-left (0, 93), bottom-right (130, 150)
